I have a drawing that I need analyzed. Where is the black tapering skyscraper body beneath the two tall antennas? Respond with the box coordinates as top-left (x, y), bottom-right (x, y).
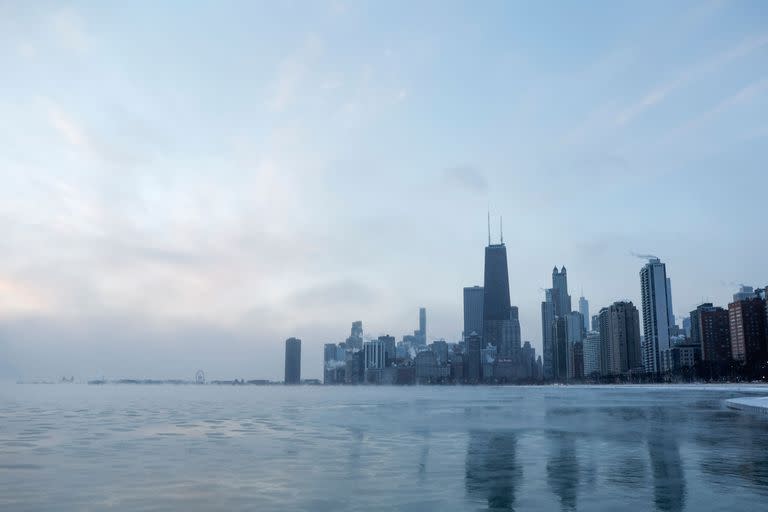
top-left (483, 229), bottom-right (511, 348)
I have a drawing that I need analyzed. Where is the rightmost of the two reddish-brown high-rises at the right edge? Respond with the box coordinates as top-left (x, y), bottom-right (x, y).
top-left (728, 295), bottom-right (768, 364)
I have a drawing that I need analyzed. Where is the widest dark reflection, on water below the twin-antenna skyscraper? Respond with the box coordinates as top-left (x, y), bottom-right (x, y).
top-left (465, 431), bottom-right (523, 510)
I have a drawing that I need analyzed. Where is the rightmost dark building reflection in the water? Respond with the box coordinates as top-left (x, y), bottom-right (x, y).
top-left (648, 410), bottom-right (686, 512)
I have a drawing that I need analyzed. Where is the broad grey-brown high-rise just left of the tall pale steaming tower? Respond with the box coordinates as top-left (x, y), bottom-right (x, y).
top-left (600, 301), bottom-right (643, 375)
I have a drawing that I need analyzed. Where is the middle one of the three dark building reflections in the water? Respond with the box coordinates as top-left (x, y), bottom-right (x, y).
top-left (547, 432), bottom-right (581, 510)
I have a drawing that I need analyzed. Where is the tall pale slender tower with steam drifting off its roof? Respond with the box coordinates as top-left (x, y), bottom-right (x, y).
top-left (640, 258), bottom-right (673, 373)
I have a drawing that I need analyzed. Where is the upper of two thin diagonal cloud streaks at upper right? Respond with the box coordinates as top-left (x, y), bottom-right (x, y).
top-left (616, 34), bottom-right (768, 126)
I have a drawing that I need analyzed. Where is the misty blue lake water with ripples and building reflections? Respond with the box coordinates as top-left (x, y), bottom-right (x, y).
top-left (0, 384), bottom-right (768, 511)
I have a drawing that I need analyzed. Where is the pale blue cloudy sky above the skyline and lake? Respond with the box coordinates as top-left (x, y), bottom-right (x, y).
top-left (0, 0), bottom-right (768, 379)
